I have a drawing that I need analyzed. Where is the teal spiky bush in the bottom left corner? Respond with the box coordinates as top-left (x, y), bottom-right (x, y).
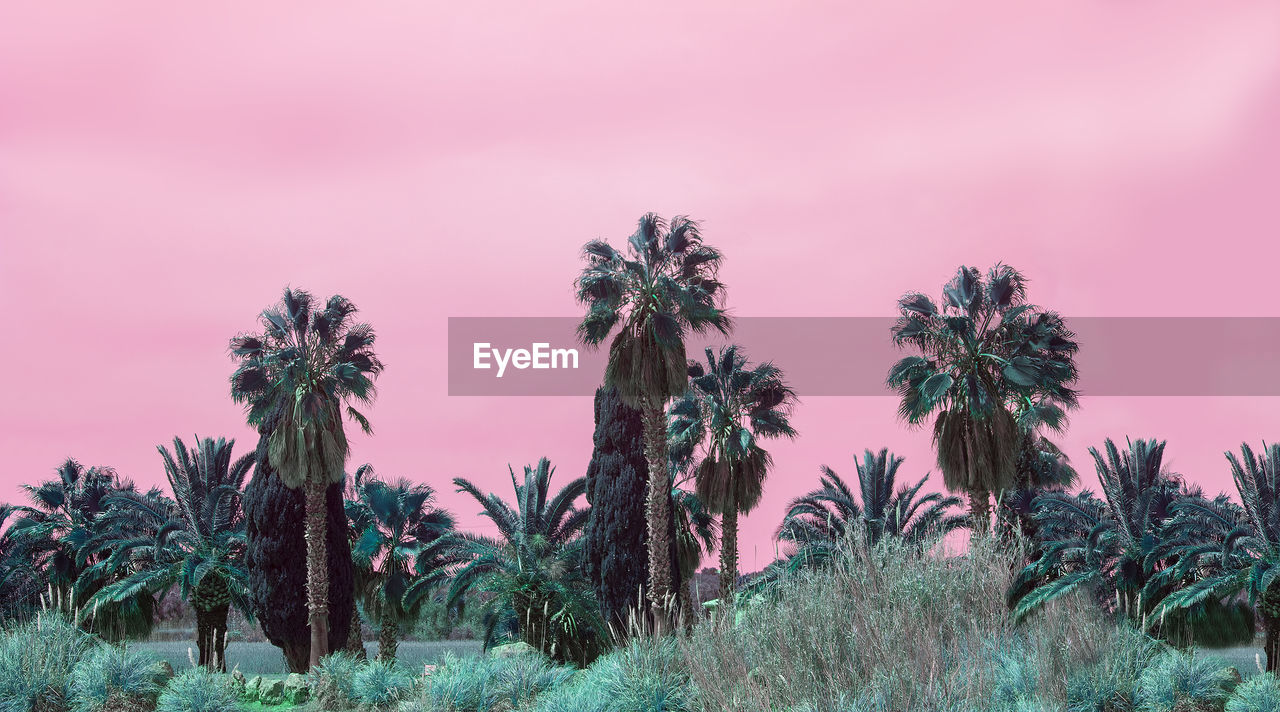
top-left (0, 613), bottom-right (95, 712)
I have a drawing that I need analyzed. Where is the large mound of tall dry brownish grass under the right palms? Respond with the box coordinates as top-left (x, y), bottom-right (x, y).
top-left (678, 533), bottom-right (1146, 712)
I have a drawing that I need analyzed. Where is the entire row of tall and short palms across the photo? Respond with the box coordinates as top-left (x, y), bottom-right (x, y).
top-left (0, 214), bottom-right (1280, 668)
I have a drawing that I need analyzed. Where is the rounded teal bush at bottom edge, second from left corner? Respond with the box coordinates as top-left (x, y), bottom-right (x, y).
top-left (70, 645), bottom-right (161, 712)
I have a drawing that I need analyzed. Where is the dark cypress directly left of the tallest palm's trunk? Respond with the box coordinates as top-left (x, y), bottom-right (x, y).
top-left (585, 388), bottom-right (649, 626)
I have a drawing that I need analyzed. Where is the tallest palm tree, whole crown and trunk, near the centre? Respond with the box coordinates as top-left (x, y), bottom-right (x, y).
top-left (575, 213), bottom-right (731, 630)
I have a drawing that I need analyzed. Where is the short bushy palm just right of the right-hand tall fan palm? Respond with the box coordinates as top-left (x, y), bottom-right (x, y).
top-left (1009, 439), bottom-right (1189, 621)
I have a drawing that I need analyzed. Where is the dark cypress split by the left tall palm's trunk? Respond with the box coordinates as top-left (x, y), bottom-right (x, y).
top-left (243, 409), bottom-right (355, 672)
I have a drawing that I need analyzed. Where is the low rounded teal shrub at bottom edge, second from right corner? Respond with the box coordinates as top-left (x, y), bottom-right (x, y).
top-left (1137, 651), bottom-right (1235, 712)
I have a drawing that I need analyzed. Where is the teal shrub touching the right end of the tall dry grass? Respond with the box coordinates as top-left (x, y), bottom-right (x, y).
top-left (1066, 626), bottom-right (1160, 712)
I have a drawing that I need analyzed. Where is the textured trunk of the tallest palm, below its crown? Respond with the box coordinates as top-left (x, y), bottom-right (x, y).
top-left (641, 398), bottom-right (673, 634)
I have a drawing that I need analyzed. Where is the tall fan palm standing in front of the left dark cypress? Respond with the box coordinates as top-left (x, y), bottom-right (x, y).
top-left (230, 288), bottom-right (383, 666)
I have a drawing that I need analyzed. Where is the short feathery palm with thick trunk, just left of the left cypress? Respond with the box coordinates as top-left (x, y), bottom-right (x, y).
top-left (86, 437), bottom-right (253, 672)
